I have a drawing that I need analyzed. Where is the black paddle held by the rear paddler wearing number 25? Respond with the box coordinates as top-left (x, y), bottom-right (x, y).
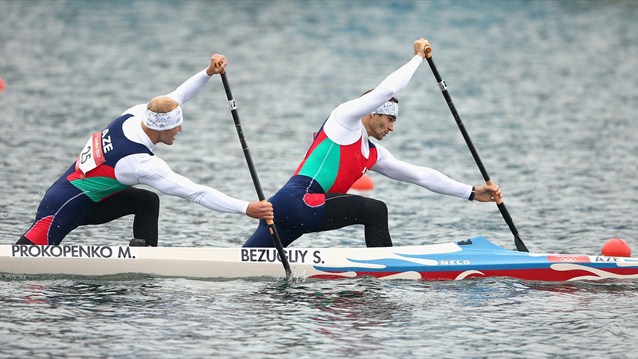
top-left (220, 72), bottom-right (292, 280)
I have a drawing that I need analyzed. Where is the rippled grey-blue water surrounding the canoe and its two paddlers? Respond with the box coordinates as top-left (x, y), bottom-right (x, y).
top-left (0, 1), bottom-right (638, 357)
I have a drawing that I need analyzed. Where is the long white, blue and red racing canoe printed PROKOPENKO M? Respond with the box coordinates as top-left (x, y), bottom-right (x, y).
top-left (0, 236), bottom-right (638, 281)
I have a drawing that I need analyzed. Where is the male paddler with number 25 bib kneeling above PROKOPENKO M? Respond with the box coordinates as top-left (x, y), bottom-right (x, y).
top-left (17, 54), bottom-right (273, 247)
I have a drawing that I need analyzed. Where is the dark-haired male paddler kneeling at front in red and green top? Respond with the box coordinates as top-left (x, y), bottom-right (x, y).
top-left (244, 38), bottom-right (502, 247)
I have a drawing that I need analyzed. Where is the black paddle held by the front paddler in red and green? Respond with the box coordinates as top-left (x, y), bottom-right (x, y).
top-left (425, 46), bottom-right (529, 252)
